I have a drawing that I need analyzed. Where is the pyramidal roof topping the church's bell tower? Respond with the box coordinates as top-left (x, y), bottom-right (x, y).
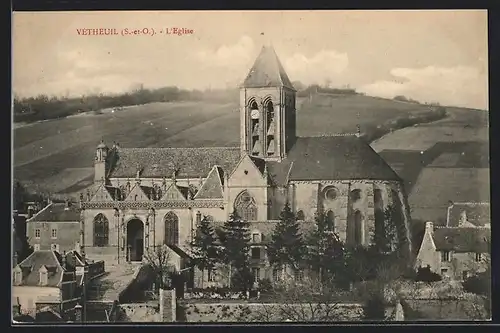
top-left (242, 46), bottom-right (295, 90)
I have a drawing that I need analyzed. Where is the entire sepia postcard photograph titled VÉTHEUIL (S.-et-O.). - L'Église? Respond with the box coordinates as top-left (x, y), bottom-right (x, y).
top-left (11, 10), bottom-right (492, 325)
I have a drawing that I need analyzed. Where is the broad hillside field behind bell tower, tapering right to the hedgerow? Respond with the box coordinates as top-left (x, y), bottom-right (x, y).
top-left (14, 96), bottom-right (434, 193)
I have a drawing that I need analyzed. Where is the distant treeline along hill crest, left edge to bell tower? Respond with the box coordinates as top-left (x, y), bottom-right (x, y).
top-left (14, 86), bottom-right (238, 122)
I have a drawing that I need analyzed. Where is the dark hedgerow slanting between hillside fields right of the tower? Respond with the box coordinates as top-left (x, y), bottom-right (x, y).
top-left (363, 106), bottom-right (446, 143)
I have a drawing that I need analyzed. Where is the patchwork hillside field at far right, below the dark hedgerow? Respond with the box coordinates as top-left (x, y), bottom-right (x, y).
top-left (372, 108), bottom-right (490, 224)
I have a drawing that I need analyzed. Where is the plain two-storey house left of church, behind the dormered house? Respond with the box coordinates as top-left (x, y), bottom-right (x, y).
top-left (26, 201), bottom-right (80, 253)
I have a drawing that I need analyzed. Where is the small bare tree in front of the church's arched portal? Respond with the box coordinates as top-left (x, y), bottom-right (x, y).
top-left (144, 245), bottom-right (175, 289)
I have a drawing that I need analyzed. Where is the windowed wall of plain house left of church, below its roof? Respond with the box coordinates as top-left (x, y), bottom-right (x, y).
top-left (27, 222), bottom-right (80, 253)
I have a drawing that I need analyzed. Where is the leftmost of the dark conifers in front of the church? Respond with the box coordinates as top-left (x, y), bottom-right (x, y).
top-left (191, 216), bottom-right (219, 283)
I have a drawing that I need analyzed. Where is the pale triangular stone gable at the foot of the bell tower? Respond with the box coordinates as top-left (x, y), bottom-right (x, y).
top-left (229, 155), bottom-right (267, 187)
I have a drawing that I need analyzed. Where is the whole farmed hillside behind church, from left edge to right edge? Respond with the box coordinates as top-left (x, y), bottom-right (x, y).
top-left (14, 95), bottom-right (489, 221)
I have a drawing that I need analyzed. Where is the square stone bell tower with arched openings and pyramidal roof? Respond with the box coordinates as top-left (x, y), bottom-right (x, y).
top-left (240, 46), bottom-right (296, 161)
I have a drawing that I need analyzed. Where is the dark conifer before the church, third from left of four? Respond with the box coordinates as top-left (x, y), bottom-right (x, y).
top-left (267, 202), bottom-right (306, 270)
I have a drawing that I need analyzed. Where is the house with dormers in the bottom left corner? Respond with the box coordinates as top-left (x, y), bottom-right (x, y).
top-left (12, 250), bottom-right (81, 318)
